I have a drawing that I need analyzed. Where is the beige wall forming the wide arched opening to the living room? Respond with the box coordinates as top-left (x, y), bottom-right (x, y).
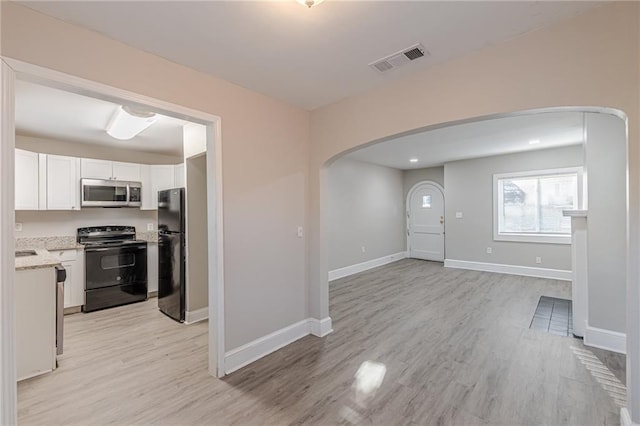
top-left (309, 2), bottom-right (639, 324)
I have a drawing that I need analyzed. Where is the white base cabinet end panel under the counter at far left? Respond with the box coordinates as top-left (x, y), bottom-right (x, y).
top-left (14, 267), bottom-right (56, 380)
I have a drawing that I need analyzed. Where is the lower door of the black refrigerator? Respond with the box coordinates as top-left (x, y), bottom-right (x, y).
top-left (158, 232), bottom-right (185, 321)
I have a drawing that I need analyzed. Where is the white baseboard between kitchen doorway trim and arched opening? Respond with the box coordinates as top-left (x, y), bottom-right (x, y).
top-left (224, 317), bottom-right (333, 374)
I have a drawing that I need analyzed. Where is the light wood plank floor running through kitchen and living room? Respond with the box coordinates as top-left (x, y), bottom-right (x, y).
top-left (18, 260), bottom-right (625, 425)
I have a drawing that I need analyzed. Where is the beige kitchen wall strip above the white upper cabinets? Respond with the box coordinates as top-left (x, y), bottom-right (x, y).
top-left (16, 135), bottom-right (183, 164)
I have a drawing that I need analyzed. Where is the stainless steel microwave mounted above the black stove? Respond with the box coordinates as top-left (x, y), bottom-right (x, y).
top-left (80, 179), bottom-right (142, 207)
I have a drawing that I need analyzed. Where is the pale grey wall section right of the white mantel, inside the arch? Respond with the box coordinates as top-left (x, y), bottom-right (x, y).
top-left (585, 113), bottom-right (627, 333)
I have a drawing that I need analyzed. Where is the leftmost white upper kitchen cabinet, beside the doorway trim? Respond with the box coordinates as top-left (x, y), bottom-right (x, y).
top-left (15, 149), bottom-right (40, 210)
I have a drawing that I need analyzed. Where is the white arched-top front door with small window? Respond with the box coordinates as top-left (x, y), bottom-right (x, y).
top-left (407, 183), bottom-right (444, 262)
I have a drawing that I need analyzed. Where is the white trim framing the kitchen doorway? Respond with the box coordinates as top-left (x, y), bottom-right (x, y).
top-left (0, 57), bottom-right (225, 424)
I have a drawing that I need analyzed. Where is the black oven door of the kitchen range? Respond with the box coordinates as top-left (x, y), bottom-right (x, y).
top-left (84, 243), bottom-right (147, 312)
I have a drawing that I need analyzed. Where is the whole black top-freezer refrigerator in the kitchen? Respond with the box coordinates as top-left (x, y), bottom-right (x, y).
top-left (158, 188), bottom-right (186, 322)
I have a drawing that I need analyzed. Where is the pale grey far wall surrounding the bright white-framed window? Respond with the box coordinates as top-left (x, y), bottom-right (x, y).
top-left (444, 145), bottom-right (584, 271)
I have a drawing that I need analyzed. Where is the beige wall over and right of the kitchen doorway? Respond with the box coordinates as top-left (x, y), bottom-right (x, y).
top-left (1, 2), bottom-right (309, 350)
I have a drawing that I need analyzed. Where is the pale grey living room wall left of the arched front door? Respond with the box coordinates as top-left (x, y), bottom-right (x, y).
top-left (329, 159), bottom-right (406, 270)
